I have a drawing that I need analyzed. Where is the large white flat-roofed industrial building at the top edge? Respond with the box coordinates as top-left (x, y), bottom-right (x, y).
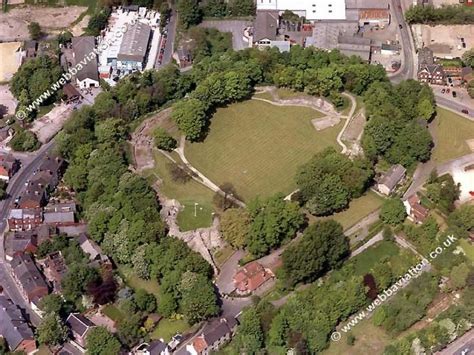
top-left (257, 0), bottom-right (346, 21)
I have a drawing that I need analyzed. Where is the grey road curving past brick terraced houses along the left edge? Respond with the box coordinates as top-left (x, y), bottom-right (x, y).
top-left (0, 141), bottom-right (54, 325)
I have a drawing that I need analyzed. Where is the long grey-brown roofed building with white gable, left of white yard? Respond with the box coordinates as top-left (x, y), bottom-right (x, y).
top-left (71, 36), bottom-right (99, 89)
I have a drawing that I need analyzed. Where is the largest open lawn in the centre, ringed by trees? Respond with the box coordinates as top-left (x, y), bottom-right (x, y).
top-left (185, 100), bottom-right (342, 201)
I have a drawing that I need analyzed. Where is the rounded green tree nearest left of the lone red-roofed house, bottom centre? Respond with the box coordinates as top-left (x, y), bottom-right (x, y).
top-left (179, 271), bottom-right (219, 324)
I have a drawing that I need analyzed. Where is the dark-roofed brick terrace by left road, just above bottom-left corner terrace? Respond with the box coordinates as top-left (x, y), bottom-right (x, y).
top-left (10, 254), bottom-right (49, 305)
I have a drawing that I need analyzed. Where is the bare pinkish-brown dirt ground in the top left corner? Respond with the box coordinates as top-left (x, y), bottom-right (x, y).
top-left (0, 6), bottom-right (87, 41)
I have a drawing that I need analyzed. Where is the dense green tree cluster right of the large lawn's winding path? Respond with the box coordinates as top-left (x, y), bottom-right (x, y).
top-left (362, 80), bottom-right (435, 167)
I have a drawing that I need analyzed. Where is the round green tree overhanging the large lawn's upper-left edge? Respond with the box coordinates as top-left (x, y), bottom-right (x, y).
top-left (171, 98), bottom-right (208, 141)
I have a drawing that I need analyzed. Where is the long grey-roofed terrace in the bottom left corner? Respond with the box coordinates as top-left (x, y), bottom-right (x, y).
top-left (0, 295), bottom-right (36, 354)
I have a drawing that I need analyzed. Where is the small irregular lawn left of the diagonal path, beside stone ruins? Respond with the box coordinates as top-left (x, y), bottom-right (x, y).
top-left (145, 152), bottom-right (214, 231)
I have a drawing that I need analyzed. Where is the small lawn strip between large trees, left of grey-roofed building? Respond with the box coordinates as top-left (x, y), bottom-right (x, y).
top-left (310, 191), bottom-right (384, 229)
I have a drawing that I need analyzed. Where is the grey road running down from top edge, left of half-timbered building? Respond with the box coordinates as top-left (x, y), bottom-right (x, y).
top-left (390, 0), bottom-right (415, 83)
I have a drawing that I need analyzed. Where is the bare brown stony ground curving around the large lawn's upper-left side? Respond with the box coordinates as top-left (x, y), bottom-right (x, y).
top-left (131, 108), bottom-right (178, 171)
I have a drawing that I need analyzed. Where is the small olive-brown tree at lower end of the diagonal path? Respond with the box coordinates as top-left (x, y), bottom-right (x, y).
top-left (219, 208), bottom-right (251, 249)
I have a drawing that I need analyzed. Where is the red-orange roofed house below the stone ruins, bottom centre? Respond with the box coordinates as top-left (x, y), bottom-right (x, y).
top-left (233, 261), bottom-right (275, 294)
